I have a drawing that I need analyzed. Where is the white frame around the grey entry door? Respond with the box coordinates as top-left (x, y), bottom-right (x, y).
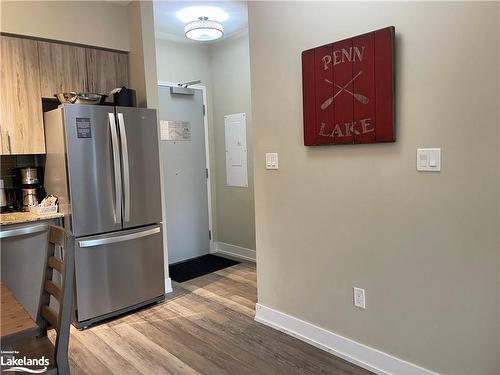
top-left (158, 80), bottom-right (215, 258)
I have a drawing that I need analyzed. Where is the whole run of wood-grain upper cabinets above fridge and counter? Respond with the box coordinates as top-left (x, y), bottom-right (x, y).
top-left (0, 35), bottom-right (129, 155)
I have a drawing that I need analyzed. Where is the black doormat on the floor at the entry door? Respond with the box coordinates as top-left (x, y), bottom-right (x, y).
top-left (168, 254), bottom-right (241, 283)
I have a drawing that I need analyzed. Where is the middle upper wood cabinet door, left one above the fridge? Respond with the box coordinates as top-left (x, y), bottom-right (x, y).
top-left (38, 42), bottom-right (88, 98)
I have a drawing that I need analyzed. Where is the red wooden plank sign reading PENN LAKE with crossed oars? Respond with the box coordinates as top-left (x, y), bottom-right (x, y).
top-left (302, 26), bottom-right (395, 146)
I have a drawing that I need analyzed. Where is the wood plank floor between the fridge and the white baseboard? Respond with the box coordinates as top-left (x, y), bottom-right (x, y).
top-left (56, 263), bottom-right (369, 375)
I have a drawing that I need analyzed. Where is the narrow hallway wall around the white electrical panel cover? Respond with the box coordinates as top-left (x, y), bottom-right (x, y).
top-left (210, 31), bottom-right (255, 250)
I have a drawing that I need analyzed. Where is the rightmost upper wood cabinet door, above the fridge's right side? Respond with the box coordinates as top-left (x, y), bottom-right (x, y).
top-left (86, 48), bottom-right (128, 101)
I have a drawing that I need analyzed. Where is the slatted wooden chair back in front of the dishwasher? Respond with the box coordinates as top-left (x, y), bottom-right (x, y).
top-left (37, 225), bottom-right (75, 374)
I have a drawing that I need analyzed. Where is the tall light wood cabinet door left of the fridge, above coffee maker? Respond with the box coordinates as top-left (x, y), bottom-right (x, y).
top-left (0, 36), bottom-right (45, 155)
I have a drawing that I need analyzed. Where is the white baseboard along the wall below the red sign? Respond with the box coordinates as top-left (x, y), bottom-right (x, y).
top-left (255, 303), bottom-right (436, 375)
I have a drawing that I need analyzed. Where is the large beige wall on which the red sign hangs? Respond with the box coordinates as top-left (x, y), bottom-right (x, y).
top-left (249, 2), bottom-right (500, 374)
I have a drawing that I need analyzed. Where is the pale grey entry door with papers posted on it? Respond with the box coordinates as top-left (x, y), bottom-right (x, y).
top-left (159, 86), bottom-right (210, 264)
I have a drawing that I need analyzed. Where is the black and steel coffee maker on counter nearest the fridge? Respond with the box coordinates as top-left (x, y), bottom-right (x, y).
top-left (14, 167), bottom-right (46, 211)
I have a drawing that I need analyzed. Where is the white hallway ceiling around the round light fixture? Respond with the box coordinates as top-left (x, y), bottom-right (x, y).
top-left (154, 0), bottom-right (248, 43)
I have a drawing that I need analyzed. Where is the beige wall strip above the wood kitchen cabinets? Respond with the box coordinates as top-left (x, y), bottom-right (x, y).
top-left (0, 1), bottom-right (130, 51)
